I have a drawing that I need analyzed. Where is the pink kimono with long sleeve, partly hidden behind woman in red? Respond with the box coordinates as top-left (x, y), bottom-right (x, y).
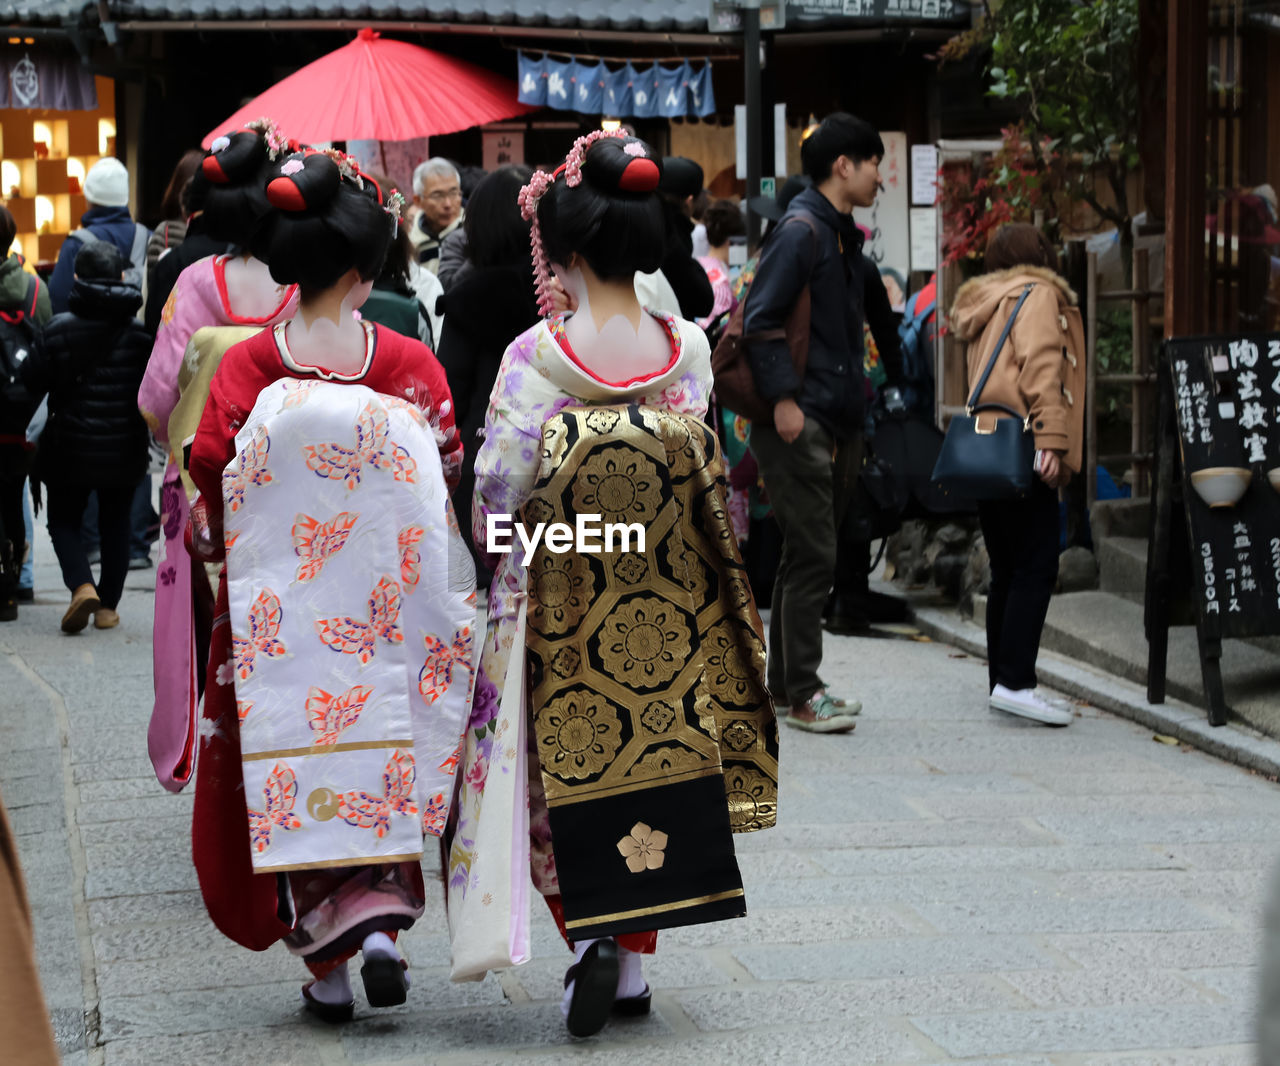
top-left (138, 256), bottom-right (297, 792)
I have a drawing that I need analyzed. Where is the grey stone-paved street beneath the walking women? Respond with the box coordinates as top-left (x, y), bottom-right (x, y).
top-left (0, 536), bottom-right (1280, 1066)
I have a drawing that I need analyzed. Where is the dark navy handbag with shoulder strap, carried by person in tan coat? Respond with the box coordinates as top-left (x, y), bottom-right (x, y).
top-left (932, 285), bottom-right (1036, 499)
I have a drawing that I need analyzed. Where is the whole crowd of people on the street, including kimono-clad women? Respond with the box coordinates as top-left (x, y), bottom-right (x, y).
top-left (0, 114), bottom-right (1080, 1037)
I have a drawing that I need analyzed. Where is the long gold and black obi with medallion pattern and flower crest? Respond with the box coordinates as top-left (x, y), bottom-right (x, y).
top-left (521, 404), bottom-right (778, 939)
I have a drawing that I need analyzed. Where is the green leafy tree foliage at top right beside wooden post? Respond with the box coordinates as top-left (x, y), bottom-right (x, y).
top-left (942, 0), bottom-right (1139, 242)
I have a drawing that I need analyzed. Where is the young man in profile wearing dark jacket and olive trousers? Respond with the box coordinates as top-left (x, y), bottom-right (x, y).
top-left (742, 113), bottom-right (884, 733)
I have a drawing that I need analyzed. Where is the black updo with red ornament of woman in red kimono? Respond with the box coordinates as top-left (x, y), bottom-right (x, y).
top-left (260, 151), bottom-right (396, 296)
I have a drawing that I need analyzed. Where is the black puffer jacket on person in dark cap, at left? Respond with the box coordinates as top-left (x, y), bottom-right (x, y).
top-left (22, 278), bottom-right (151, 486)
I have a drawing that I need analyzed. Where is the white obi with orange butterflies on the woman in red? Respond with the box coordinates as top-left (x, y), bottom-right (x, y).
top-left (223, 379), bottom-right (475, 873)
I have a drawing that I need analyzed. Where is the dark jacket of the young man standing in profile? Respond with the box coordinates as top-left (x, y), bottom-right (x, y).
top-left (742, 188), bottom-right (880, 438)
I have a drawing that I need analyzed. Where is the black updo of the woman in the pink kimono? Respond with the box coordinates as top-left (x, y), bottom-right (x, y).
top-left (186, 128), bottom-right (271, 251)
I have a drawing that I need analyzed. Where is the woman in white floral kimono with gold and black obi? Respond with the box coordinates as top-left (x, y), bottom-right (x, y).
top-left (449, 133), bottom-right (777, 1037)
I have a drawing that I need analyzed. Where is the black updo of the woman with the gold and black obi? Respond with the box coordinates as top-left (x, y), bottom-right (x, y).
top-left (538, 137), bottom-right (666, 280)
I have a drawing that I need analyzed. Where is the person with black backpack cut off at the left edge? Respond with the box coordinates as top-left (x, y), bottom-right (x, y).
top-left (0, 207), bottom-right (50, 622)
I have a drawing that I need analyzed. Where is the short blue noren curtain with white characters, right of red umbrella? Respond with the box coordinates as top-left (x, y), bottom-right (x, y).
top-left (516, 51), bottom-right (716, 119)
